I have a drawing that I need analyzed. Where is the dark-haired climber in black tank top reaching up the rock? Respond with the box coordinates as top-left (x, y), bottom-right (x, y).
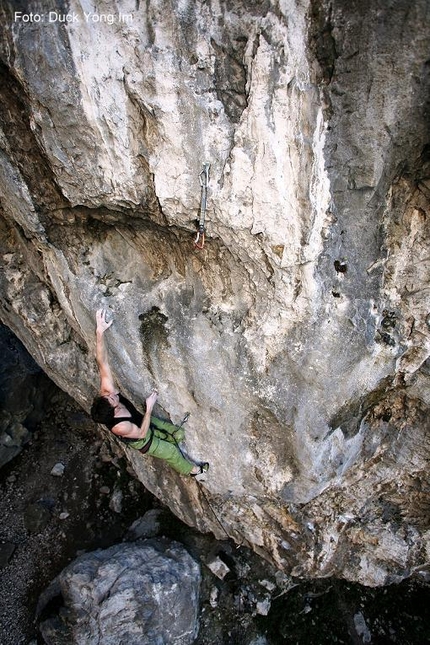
top-left (91, 309), bottom-right (209, 477)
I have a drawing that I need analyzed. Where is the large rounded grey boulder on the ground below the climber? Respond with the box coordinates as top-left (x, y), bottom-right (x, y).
top-left (40, 540), bottom-right (200, 645)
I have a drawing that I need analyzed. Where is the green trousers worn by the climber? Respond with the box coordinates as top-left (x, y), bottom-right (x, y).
top-left (142, 417), bottom-right (194, 475)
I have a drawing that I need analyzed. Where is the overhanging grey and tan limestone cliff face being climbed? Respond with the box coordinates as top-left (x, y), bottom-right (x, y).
top-left (0, 0), bottom-right (430, 585)
